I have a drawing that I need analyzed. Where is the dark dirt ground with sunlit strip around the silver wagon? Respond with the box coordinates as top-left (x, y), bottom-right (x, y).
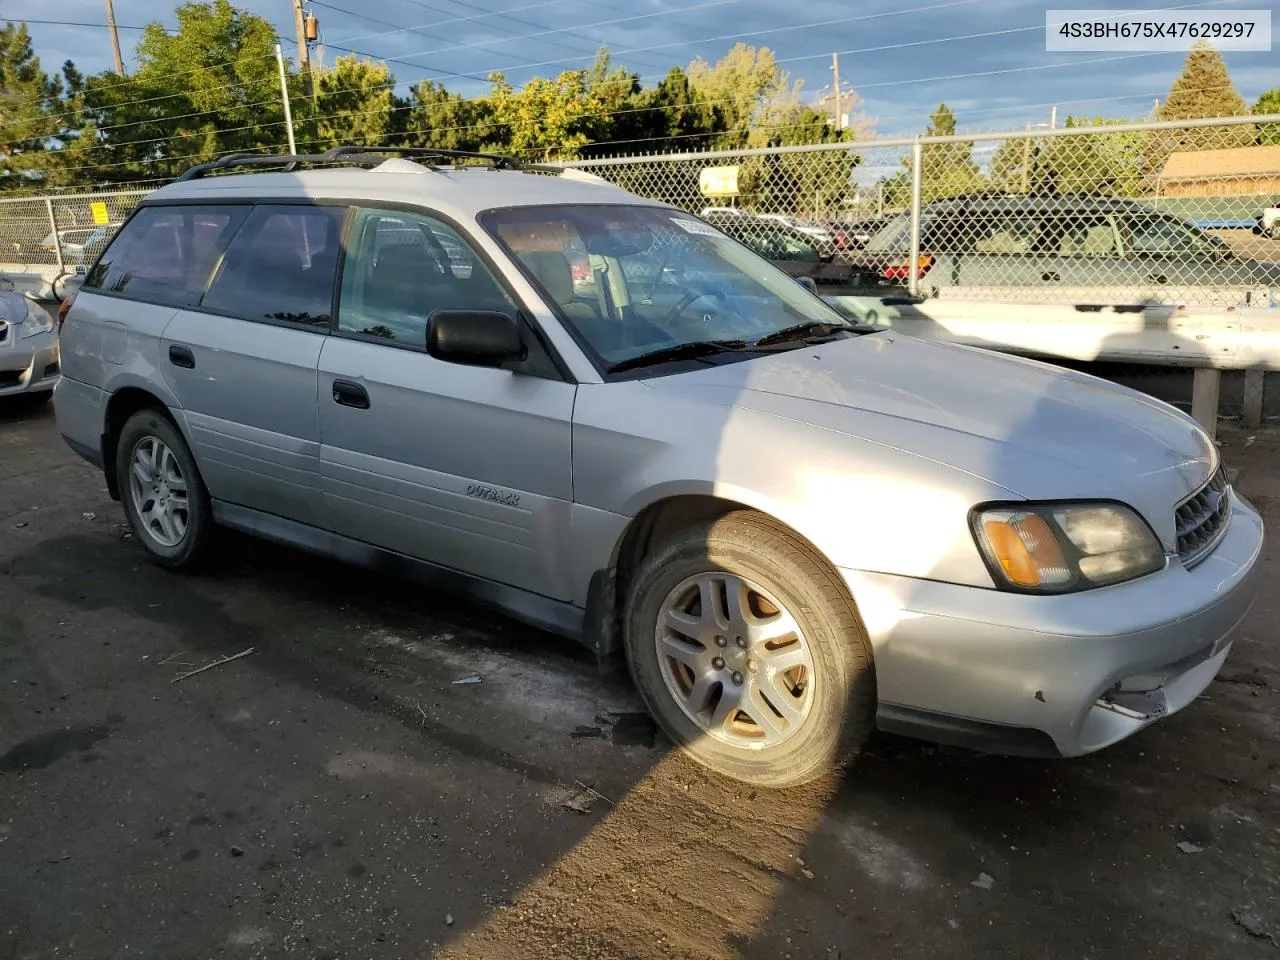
top-left (0, 399), bottom-right (1280, 960)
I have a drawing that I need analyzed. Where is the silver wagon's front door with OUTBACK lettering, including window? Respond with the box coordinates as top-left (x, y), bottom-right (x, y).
top-left (319, 209), bottom-right (576, 599)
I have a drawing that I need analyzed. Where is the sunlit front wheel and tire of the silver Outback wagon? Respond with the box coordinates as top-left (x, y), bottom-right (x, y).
top-left (626, 511), bottom-right (876, 787)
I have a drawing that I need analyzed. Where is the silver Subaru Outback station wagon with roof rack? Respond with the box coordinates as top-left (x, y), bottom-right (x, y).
top-left (55, 148), bottom-right (1263, 786)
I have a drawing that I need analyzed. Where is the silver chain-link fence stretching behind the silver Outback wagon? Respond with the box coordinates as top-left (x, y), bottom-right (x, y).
top-left (0, 115), bottom-right (1280, 420)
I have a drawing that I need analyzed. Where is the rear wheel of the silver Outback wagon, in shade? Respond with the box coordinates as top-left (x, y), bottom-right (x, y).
top-left (115, 410), bottom-right (214, 570)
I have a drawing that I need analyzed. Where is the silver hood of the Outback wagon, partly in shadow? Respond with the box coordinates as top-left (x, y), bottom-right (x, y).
top-left (648, 333), bottom-right (1217, 542)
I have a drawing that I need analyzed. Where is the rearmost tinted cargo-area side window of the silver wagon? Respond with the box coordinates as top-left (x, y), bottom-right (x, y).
top-left (82, 206), bottom-right (248, 307)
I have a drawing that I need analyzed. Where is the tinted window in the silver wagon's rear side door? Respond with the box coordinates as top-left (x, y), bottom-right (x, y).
top-left (201, 204), bottom-right (347, 328)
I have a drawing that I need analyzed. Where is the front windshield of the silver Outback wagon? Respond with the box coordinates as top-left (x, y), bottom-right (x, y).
top-left (481, 205), bottom-right (850, 366)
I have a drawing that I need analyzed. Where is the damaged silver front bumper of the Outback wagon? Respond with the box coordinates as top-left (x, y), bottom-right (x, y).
top-left (842, 490), bottom-right (1263, 756)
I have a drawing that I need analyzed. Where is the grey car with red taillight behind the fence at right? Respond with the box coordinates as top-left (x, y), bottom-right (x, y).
top-left (860, 196), bottom-right (1280, 303)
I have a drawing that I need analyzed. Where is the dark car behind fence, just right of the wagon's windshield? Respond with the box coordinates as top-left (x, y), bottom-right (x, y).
top-left (705, 214), bottom-right (909, 300)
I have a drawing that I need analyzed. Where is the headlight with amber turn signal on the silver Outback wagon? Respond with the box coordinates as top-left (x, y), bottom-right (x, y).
top-left (972, 503), bottom-right (1165, 594)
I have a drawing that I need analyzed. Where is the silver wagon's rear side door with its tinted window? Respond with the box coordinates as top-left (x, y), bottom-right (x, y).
top-left (160, 204), bottom-right (347, 526)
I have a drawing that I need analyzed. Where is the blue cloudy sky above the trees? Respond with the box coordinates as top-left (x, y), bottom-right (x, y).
top-left (10, 0), bottom-right (1280, 136)
